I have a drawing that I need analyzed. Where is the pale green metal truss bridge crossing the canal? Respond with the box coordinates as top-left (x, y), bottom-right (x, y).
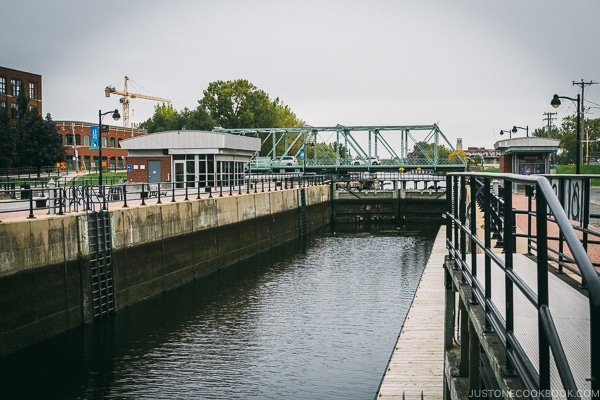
top-left (213, 124), bottom-right (468, 172)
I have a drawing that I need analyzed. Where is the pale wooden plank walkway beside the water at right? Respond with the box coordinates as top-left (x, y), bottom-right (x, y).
top-left (376, 226), bottom-right (448, 400)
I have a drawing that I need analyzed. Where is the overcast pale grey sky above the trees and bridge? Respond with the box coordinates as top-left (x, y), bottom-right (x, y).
top-left (0, 0), bottom-right (600, 148)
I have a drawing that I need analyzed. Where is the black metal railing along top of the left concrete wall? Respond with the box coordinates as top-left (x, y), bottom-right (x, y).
top-left (0, 174), bottom-right (328, 218)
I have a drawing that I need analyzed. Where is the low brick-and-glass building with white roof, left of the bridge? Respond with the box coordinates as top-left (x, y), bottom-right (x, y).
top-left (121, 130), bottom-right (261, 188)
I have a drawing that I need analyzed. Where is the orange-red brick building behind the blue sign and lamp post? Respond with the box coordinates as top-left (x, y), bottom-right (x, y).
top-left (54, 121), bottom-right (146, 172)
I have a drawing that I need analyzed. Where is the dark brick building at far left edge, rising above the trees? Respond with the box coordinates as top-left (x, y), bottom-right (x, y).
top-left (0, 67), bottom-right (42, 120)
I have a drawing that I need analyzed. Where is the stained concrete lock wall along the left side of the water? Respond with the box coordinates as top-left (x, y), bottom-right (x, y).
top-left (0, 186), bottom-right (331, 355)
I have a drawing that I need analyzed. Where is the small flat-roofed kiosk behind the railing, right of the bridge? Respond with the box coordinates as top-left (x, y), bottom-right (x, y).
top-left (494, 137), bottom-right (560, 175)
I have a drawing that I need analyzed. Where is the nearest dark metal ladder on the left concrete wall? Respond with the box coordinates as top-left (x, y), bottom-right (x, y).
top-left (88, 211), bottom-right (115, 319)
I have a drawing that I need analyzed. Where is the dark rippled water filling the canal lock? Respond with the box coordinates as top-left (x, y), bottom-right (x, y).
top-left (0, 225), bottom-right (436, 399)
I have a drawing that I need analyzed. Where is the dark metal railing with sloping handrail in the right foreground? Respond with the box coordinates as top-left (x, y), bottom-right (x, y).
top-left (446, 173), bottom-right (600, 398)
